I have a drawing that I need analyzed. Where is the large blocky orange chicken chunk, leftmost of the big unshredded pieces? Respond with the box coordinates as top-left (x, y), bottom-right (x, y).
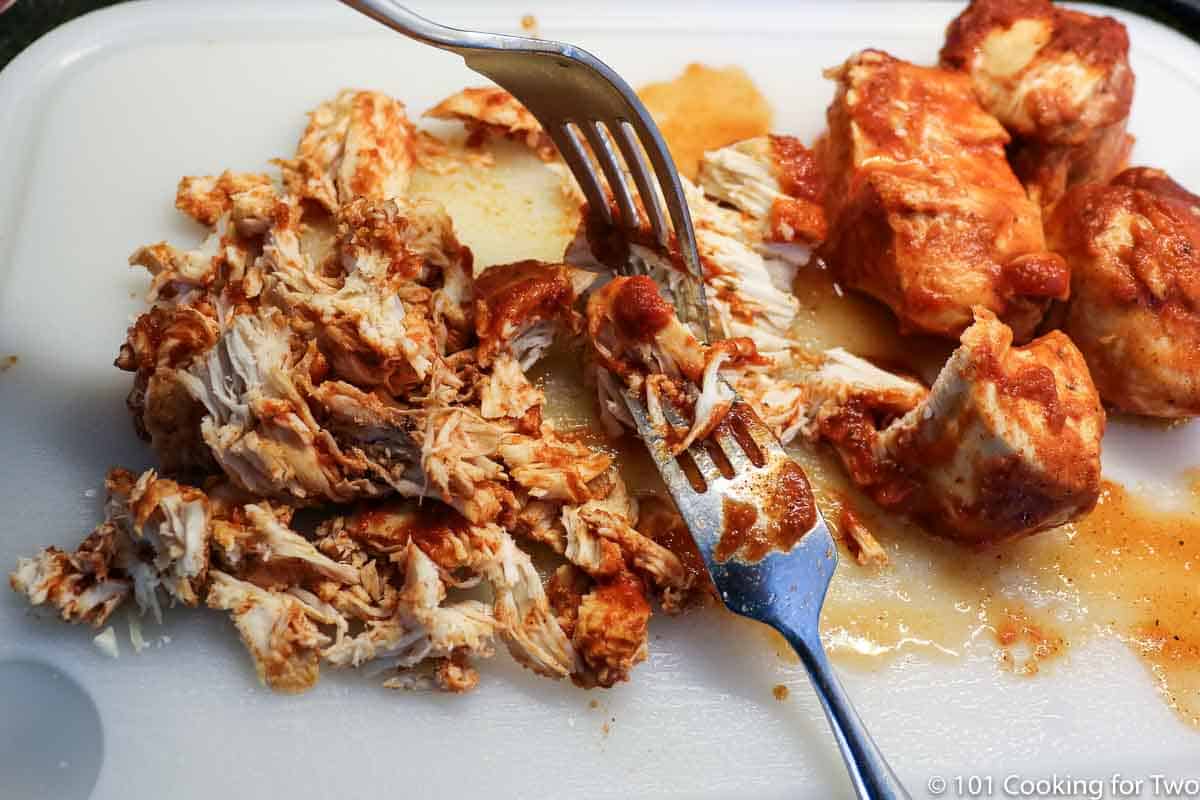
top-left (817, 50), bottom-right (1069, 341)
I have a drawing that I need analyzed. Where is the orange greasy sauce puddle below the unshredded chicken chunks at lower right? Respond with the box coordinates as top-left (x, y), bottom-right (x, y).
top-left (796, 431), bottom-right (1200, 727)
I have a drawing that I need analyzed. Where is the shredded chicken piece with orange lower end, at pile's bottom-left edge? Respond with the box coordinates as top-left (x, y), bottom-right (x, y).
top-left (208, 570), bottom-right (330, 692)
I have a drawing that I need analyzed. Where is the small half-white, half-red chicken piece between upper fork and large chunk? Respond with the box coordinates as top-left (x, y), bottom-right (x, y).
top-left (697, 134), bottom-right (826, 246)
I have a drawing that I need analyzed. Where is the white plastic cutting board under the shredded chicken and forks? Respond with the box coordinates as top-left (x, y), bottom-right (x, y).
top-left (0, 0), bottom-right (1200, 800)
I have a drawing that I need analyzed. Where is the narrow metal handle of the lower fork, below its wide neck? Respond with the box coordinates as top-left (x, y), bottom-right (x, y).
top-left (778, 626), bottom-right (910, 800)
